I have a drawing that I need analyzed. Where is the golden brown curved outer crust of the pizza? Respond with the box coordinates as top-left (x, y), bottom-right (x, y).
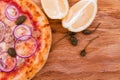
top-left (2, 0), bottom-right (51, 80)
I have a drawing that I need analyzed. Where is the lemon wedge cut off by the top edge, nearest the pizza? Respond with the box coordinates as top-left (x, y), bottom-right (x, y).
top-left (41, 0), bottom-right (69, 19)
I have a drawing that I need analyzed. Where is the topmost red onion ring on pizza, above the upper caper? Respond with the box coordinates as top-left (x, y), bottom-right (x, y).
top-left (5, 4), bottom-right (20, 21)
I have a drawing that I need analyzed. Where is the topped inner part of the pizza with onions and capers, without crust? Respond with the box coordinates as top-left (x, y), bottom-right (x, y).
top-left (0, 0), bottom-right (41, 72)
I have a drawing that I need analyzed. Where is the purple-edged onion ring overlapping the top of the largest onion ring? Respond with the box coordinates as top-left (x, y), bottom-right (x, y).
top-left (14, 24), bottom-right (32, 40)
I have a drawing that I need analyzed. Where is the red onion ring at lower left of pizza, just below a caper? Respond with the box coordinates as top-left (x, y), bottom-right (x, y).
top-left (0, 52), bottom-right (17, 72)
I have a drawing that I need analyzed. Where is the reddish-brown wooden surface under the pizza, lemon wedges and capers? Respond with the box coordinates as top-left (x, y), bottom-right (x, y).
top-left (33, 0), bottom-right (120, 80)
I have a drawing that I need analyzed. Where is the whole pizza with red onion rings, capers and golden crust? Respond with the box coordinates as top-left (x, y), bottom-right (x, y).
top-left (0, 0), bottom-right (51, 80)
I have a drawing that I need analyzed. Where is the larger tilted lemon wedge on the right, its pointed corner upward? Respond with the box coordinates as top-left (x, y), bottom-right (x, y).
top-left (62, 0), bottom-right (97, 32)
